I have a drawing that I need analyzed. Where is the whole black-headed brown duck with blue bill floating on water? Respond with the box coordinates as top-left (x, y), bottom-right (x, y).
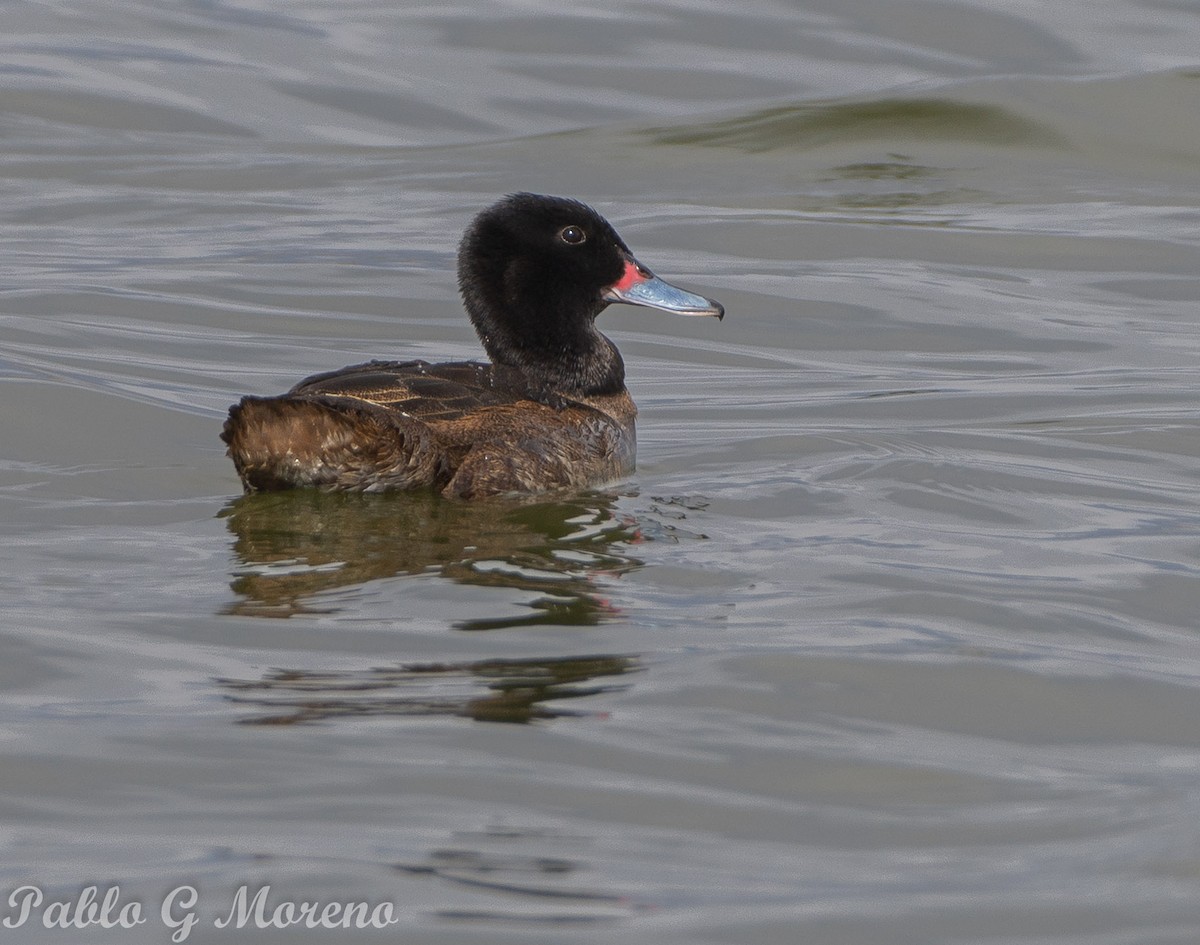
top-left (221, 193), bottom-right (725, 499)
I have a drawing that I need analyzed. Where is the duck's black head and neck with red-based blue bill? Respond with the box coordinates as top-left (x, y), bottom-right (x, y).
top-left (458, 193), bottom-right (725, 396)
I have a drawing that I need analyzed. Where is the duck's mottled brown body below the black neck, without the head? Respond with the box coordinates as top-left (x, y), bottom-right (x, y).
top-left (222, 361), bottom-right (636, 498)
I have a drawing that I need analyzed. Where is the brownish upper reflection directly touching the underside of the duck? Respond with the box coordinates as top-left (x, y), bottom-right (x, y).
top-left (222, 490), bottom-right (638, 630)
